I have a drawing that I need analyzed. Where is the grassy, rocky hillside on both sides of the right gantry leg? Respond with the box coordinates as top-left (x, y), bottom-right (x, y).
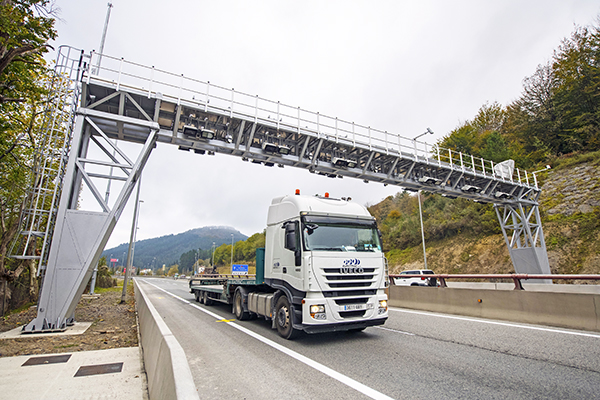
top-left (382, 152), bottom-right (600, 274)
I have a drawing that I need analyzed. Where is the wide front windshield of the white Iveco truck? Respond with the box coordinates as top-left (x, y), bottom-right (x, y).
top-left (302, 217), bottom-right (381, 252)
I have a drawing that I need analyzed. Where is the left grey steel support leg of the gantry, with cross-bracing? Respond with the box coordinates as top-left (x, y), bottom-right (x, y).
top-left (23, 109), bottom-right (159, 333)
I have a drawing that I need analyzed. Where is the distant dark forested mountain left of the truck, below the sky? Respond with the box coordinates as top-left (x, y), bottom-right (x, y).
top-left (102, 226), bottom-right (248, 270)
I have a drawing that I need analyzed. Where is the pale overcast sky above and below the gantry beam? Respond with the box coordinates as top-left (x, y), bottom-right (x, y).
top-left (50, 0), bottom-right (600, 248)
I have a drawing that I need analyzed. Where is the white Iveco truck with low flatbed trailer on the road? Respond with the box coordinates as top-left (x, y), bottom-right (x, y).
top-left (189, 190), bottom-right (389, 339)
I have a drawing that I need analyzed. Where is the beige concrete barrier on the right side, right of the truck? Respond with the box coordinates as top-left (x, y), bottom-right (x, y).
top-left (389, 285), bottom-right (600, 332)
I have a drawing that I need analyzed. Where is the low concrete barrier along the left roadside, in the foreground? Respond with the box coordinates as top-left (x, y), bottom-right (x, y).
top-left (133, 279), bottom-right (199, 400)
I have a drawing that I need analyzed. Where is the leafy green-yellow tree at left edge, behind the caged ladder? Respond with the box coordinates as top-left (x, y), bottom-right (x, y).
top-left (0, 0), bottom-right (56, 314)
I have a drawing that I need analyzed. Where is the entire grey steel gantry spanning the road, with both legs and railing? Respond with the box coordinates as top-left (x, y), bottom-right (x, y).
top-left (16, 47), bottom-right (550, 330)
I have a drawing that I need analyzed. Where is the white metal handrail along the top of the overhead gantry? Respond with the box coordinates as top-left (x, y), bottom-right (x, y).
top-left (82, 47), bottom-right (539, 189)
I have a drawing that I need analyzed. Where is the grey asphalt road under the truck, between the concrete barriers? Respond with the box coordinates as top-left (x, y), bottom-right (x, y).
top-left (138, 278), bottom-right (600, 400)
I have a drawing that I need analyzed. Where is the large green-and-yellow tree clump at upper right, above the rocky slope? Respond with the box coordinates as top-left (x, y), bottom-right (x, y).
top-left (503, 20), bottom-right (600, 164)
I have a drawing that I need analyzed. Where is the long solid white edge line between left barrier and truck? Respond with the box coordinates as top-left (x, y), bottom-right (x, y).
top-left (143, 280), bottom-right (392, 400)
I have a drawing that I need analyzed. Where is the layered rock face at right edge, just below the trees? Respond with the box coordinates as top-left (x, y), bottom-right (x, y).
top-left (540, 164), bottom-right (600, 216)
